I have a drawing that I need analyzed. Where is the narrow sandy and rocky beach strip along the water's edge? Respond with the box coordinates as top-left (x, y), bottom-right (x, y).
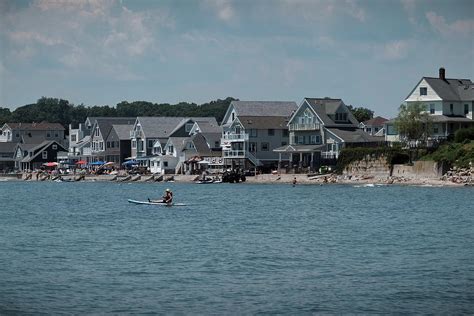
top-left (0, 174), bottom-right (474, 187)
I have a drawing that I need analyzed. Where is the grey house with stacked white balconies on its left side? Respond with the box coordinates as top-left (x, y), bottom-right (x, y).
top-left (221, 101), bottom-right (297, 169)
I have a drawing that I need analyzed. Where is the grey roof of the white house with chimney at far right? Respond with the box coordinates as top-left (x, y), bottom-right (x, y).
top-left (422, 77), bottom-right (474, 101)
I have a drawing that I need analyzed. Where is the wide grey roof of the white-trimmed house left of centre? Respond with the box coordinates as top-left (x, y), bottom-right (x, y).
top-left (137, 116), bottom-right (186, 138)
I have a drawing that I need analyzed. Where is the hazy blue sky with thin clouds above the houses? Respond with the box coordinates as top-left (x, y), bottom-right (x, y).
top-left (0, 0), bottom-right (474, 118)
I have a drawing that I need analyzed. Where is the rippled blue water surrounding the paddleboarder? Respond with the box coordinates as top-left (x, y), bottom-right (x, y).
top-left (0, 182), bottom-right (474, 314)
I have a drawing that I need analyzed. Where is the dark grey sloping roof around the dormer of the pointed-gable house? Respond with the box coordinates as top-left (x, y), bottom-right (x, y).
top-left (305, 98), bottom-right (359, 127)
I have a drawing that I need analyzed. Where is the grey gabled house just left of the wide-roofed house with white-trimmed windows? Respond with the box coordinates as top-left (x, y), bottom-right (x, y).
top-left (90, 117), bottom-right (135, 165)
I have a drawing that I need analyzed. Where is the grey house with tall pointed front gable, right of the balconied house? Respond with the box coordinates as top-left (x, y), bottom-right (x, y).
top-left (274, 97), bottom-right (380, 171)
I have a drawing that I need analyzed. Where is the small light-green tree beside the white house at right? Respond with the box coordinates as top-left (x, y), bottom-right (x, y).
top-left (395, 102), bottom-right (432, 146)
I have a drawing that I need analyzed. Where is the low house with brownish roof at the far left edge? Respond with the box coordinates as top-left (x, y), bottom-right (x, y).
top-left (0, 121), bottom-right (66, 145)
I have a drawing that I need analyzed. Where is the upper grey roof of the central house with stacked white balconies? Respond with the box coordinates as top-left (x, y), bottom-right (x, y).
top-left (230, 101), bottom-right (298, 117)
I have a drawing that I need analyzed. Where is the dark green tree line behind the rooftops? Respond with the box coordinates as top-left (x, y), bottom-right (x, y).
top-left (0, 97), bottom-right (374, 128)
